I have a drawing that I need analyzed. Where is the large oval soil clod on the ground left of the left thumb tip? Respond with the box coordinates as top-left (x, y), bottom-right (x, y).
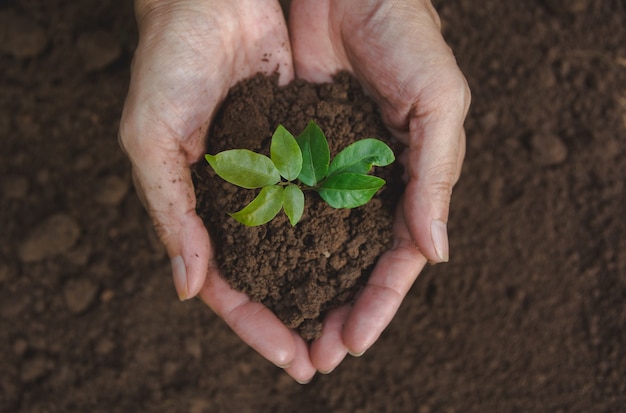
top-left (18, 213), bottom-right (80, 262)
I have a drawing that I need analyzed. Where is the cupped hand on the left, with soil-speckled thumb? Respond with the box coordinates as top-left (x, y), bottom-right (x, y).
top-left (120, 0), bottom-right (315, 382)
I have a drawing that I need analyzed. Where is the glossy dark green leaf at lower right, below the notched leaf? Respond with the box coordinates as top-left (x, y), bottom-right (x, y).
top-left (319, 172), bottom-right (385, 208)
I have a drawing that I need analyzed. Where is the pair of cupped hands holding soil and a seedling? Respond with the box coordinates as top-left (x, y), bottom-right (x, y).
top-left (120, 0), bottom-right (470, 383)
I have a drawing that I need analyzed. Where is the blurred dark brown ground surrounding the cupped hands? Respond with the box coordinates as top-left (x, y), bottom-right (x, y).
top-left (0, 0), bottom-right (626, 413)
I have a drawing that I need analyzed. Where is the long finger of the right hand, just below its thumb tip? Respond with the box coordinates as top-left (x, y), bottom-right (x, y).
top-left (343, 200), bottom-right (426, 356)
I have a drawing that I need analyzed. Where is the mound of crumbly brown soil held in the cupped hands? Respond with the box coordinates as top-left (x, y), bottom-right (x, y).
top-left (194, 74), bottom-right (402, 340)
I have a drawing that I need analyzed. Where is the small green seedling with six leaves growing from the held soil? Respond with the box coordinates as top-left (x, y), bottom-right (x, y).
top-left (205, 121), bottom-right (395, 226)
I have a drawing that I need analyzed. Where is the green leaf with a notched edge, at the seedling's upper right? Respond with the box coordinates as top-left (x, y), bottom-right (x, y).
top-left (328, 138), bottom-right (396, 176)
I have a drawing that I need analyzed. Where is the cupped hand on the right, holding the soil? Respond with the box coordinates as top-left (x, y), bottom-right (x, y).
top-left (289, 0), bottom-right (470, 372)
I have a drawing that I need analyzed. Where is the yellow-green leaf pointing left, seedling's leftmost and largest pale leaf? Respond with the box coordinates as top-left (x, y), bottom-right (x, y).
top-left (205, 149), bottom-right (280, 189)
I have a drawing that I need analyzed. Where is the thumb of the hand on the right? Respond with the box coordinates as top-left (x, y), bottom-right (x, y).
top-left (404, 69), bottom-right (470, 262)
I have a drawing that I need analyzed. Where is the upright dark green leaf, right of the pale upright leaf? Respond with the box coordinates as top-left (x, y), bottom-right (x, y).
top-left (296, 121), bottom-right (330, 186)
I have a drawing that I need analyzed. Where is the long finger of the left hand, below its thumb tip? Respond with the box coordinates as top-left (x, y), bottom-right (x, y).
top-left (200, 266), bottom-right (298, 368)
